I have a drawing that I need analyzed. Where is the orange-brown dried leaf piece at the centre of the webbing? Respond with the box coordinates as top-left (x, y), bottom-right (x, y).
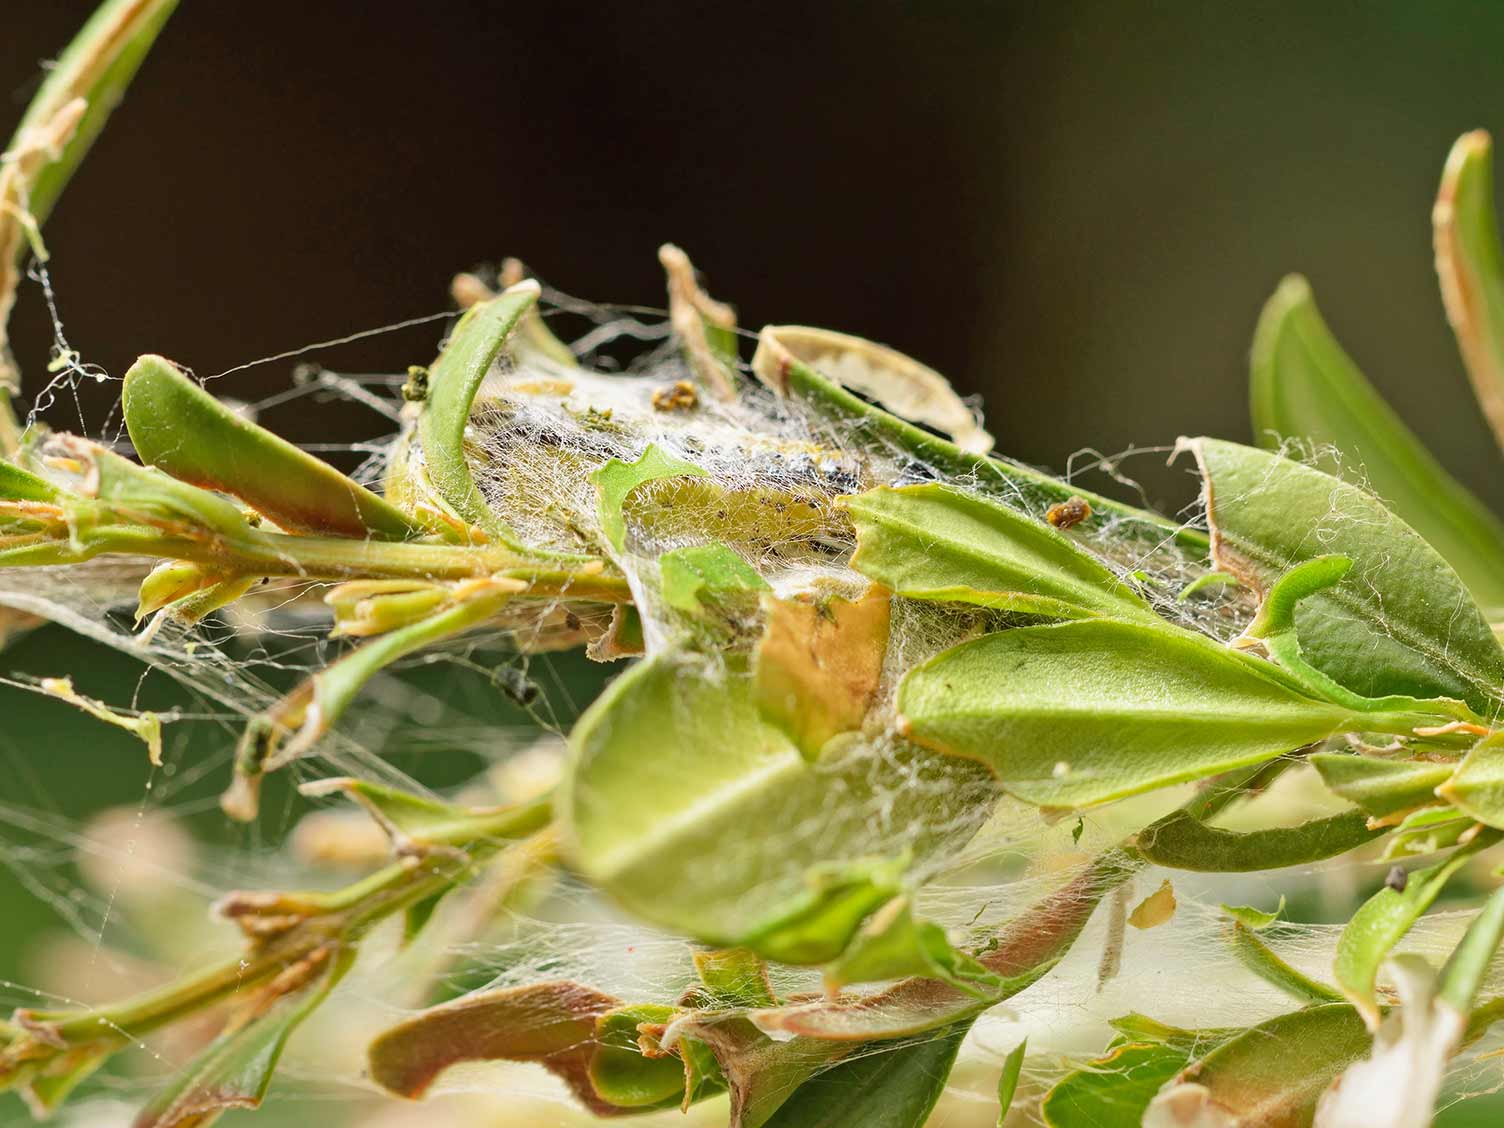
top-left (752, 584), bottom-right (890, 760)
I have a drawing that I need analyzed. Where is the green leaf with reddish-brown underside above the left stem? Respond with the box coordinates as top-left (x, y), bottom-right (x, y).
top-left (120, 356), bottom-right (426, 540)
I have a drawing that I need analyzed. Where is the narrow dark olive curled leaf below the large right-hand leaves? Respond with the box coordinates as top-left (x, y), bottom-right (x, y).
top-left (1137, 811), bottom-right (1384, 874)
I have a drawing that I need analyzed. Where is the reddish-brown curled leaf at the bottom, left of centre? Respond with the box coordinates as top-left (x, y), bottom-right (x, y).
top-left (367, 981), bottom-right (621, 1116)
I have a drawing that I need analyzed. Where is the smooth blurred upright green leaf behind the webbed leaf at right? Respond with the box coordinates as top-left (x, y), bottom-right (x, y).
top-left (1251, 275), bottom-right (1504, 614)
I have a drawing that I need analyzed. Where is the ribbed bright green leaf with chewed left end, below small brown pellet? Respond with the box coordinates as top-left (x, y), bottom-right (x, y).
top-left (841, 484), bottom-right (1154, 618)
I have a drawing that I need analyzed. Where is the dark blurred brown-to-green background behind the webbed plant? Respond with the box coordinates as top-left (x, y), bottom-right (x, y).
top-left (0, 0), bottom-right (1504, 1120)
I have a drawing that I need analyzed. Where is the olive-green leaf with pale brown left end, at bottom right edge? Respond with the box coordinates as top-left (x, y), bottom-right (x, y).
top-left (1143, 1003), bottom-right (1372, 1128)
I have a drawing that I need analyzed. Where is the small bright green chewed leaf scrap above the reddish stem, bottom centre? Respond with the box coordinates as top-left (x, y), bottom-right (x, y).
top-left (826, 896), bottom-right (1003, 999)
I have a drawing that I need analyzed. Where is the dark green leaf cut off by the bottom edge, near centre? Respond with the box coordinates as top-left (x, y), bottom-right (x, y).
top-left (766, 1021), bottom-right (972, 1128)
